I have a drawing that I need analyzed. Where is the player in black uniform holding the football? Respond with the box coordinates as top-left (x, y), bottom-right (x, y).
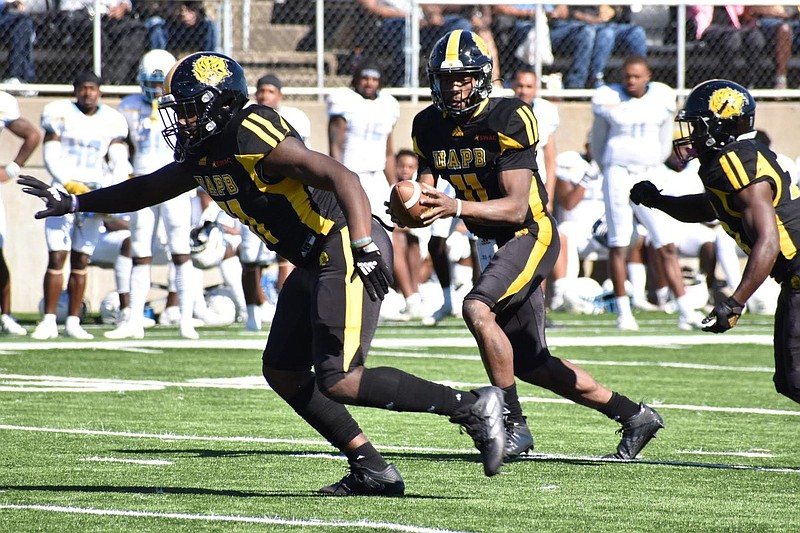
top-left (404, 30), bottom-right (663, 459)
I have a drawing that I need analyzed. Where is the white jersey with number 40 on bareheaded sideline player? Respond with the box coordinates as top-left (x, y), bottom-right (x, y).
top-left (42, 100), bottom-right (128, 187)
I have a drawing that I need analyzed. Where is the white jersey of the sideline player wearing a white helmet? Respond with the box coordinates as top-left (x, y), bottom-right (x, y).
top-left (119, 94), bottom-right (175, 176)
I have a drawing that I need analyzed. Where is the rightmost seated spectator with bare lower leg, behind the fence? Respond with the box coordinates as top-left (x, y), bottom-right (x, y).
top-left (744, 6), bottom-right (800, 89)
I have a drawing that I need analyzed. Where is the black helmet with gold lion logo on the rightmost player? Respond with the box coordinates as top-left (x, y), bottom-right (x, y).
top-left (672, 80), bottom-right (756, 164)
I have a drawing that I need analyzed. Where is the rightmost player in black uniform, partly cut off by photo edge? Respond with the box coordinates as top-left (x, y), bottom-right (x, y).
top-left (631, 80), bottom-right (800, 403)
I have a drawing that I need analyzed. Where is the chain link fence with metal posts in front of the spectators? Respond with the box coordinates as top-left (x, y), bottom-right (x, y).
top-left (6, 0), bottom-right (800, 97)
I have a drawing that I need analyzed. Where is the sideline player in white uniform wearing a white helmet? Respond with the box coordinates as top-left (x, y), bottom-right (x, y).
top-left (105, 49), bottom-right (198, 339)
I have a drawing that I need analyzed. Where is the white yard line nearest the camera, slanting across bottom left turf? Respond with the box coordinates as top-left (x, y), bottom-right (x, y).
top-left (0, 504), bottom-right (465, 533)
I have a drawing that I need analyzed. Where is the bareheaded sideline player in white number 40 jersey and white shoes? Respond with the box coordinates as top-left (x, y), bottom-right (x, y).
top-left (31, 72), bottom-right (131, 340)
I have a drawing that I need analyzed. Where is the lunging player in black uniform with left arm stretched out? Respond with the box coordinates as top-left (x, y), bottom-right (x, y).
top-left (19, 52), bottom-right (505, 495)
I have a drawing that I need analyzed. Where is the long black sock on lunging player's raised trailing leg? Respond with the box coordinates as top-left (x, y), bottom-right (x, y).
top-left (357, 367), bottom-right (476, 416)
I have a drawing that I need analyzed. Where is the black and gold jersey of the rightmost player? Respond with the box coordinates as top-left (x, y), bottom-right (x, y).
top-left (699, 138), bottom-right (800, 280)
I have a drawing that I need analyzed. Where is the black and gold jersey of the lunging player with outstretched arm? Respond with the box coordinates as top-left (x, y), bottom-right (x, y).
top-left (181, 105), bottom-right (345, 266)
